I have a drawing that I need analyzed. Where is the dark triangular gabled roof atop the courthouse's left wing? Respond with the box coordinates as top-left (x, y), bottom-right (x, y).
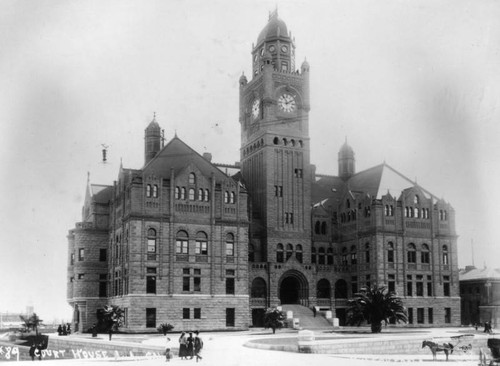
top-left (142, 136), bottom-right (232, 181)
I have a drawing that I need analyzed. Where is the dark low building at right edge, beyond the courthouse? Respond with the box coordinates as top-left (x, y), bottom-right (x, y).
top-left (459, 266), bottom-right (500, 328)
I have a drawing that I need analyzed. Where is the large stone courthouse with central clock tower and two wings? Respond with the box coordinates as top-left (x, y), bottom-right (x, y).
top-left (67, 12), bottom-right (460, 332)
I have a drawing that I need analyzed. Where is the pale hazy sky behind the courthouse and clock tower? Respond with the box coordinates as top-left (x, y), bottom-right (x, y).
top-left (0, 0), bottom-right (500, 320)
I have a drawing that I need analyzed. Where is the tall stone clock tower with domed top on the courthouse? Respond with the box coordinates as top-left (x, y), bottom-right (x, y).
top-left (240, 11), bottom-right (312, 305)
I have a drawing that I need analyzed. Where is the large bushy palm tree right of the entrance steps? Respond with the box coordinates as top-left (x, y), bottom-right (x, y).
top-left (347, 286), bottom-right (408, 333)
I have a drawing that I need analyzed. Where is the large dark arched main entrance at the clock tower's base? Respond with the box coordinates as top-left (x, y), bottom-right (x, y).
top-left (278, 269), bottom-right (309, 306)
